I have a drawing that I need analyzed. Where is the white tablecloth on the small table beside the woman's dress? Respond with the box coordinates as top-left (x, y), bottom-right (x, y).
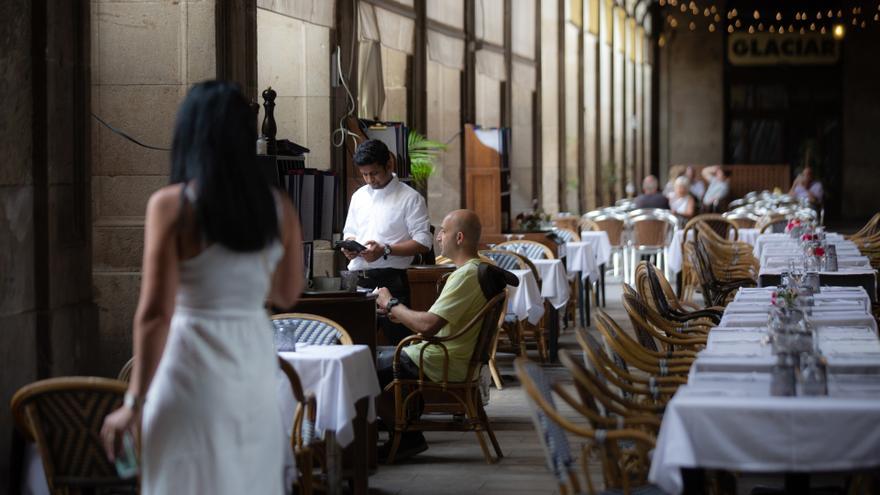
top-left (278, 344), bottom-right (382, 447)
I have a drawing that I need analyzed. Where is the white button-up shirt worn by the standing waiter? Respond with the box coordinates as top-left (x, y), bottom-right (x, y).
top-left (342, 174), bottom-right (433, 270)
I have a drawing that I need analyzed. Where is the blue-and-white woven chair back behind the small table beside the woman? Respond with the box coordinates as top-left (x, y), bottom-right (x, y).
top-left (272, 313), bottom-right (352, 352)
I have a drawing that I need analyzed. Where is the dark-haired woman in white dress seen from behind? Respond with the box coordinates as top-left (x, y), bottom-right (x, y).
top-left (101, 81), bottom-right (303, 494)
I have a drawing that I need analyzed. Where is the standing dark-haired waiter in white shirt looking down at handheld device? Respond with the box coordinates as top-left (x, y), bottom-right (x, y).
top-left (342, 140), bottom-right (433, 345)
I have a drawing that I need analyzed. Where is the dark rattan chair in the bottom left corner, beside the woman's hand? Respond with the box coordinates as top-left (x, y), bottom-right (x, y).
top-left (11, 377), bottom-right (138, 495)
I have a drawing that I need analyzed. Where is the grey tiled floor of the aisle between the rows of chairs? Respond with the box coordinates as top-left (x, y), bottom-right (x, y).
top-left (370, 283), bottom-right (630, 495)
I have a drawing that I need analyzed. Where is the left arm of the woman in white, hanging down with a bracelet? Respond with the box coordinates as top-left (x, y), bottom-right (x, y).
top-left (101, 186), bottom-right (181, 459)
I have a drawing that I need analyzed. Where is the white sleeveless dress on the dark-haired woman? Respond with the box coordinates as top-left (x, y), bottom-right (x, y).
top-left (141, 200), bottom-right (286, 495)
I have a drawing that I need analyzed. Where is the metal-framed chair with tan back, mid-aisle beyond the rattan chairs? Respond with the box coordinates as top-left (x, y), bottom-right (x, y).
top-left (625, 208), bottom-right (678, 282)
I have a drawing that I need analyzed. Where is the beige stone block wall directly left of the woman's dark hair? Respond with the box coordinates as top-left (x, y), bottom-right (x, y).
top-left (91, 0), bottom-right (216, 375)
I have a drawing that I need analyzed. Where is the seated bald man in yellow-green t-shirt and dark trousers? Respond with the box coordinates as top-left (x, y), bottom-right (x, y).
top-left (376, 210), bottom-right (486, 459)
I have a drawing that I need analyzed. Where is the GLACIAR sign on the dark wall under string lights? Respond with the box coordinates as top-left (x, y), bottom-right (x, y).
top-left (727, 33), bottom-right (840, 65)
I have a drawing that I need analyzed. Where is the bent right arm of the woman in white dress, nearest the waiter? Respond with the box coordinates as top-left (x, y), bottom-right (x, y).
top-left (269, 195), bottom-right (305, 308)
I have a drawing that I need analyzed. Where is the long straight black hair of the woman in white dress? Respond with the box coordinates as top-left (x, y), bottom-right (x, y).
top-left (171, 81), bottom-right (279, 251)
